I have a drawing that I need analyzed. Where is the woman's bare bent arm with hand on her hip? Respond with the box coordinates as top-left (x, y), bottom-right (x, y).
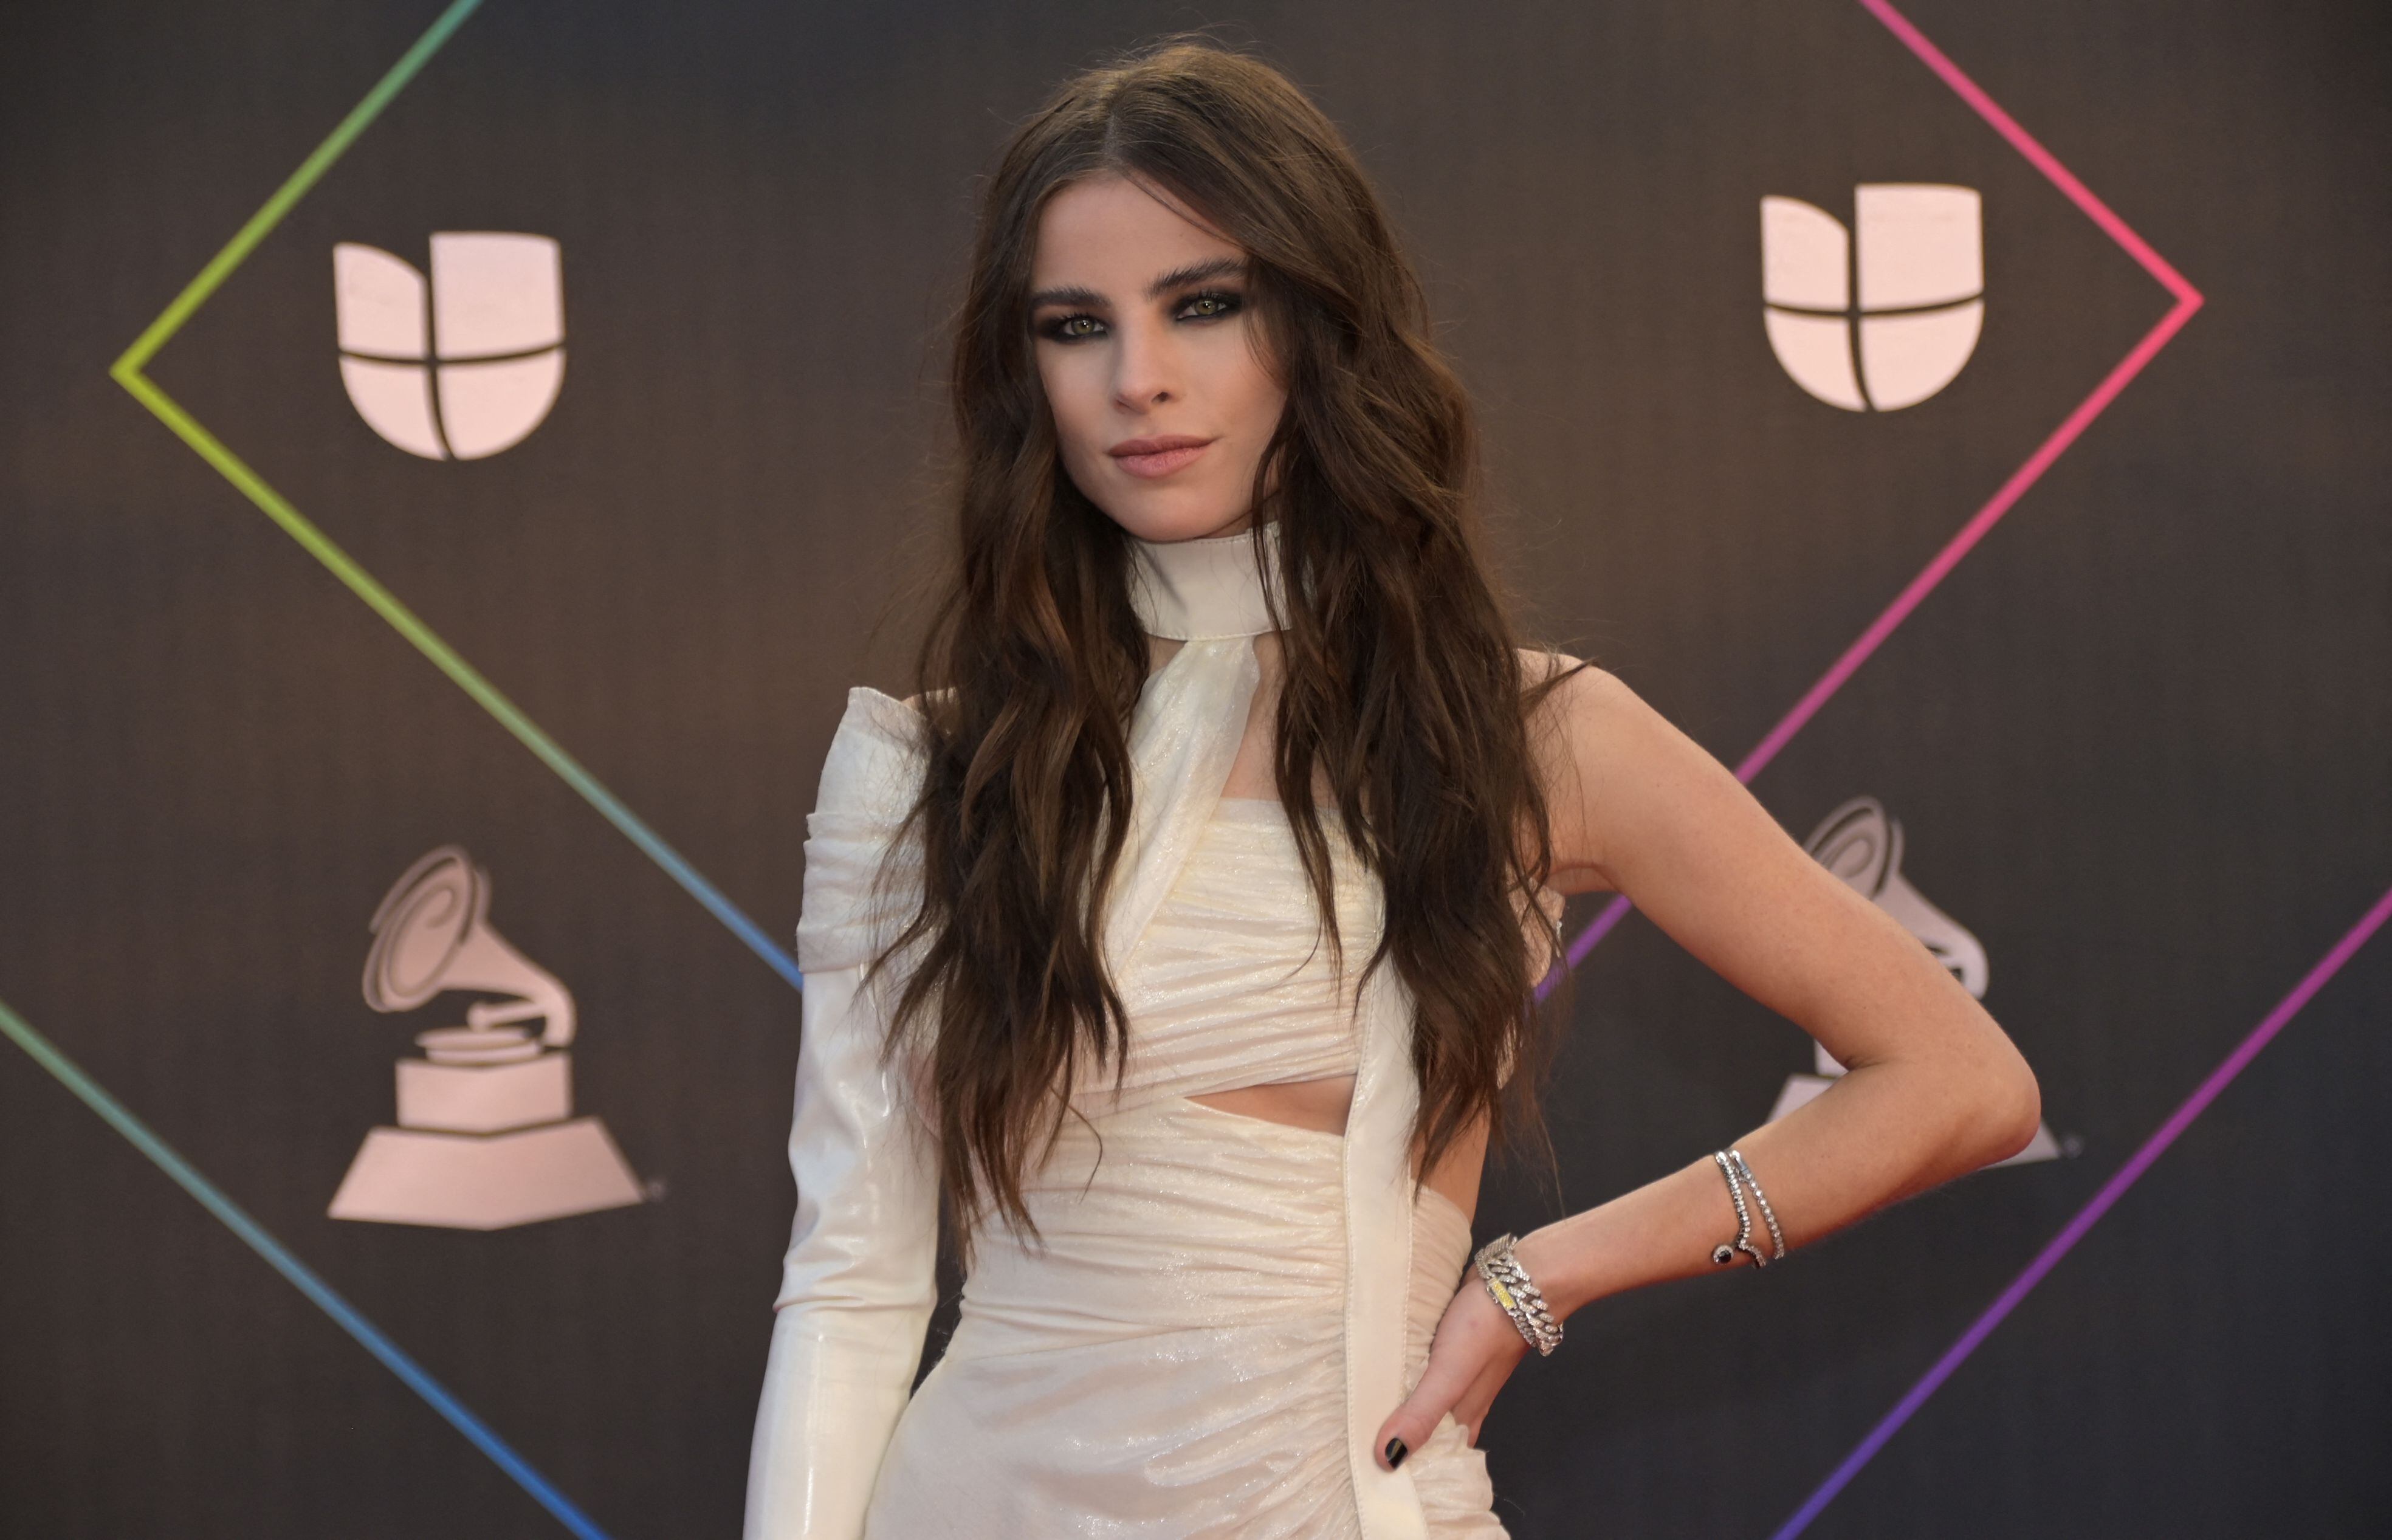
top-left (1380, 667), bottom-right (2040, 1449)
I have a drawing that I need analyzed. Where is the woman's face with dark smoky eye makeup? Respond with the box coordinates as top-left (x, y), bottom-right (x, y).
top-left (1031, 174), bottom-right (1287, 540)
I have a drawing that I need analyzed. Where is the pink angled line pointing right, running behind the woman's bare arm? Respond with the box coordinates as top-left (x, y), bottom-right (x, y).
top-left (1536, 0), bottom-right (2203, 1000)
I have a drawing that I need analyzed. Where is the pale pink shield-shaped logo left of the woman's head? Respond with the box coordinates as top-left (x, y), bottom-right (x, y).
top-left (332, 230), bottom-right (565, 459)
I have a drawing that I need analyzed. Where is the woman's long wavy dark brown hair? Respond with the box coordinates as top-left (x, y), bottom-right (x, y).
top-left (882, 38), bottom-right (1559, 1256)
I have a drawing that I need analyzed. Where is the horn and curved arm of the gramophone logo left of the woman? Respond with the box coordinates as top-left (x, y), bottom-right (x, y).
top-left (366, 844), bottom-right (574, 1047)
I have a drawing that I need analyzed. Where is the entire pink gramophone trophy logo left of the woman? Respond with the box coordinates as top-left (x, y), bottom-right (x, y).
top-left (330, 844), bottom-right (641, 1229)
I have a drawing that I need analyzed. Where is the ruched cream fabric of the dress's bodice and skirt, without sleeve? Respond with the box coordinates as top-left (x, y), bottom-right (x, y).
top-left (866, 799), bottom-right (1505, 1540)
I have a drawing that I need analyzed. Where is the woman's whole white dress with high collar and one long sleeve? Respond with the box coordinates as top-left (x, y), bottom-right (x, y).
top-left (746, 523), bottom-right (1505, 1540)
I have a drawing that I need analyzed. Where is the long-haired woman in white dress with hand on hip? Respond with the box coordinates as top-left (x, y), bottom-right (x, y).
top-left (749, 43), bottom-right (2038, 1540)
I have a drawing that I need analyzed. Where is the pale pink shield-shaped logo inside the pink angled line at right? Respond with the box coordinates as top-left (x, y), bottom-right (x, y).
top-left (1761, 182), bottom-right (1985, 411)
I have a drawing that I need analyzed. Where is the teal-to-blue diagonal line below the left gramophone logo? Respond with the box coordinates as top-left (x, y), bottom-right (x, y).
top-left (0, 1000), bottom-right (608, 1540)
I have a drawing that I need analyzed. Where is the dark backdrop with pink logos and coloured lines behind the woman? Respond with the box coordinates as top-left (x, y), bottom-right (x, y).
top-left (0, 0), bottom-right (2392, 1540)
